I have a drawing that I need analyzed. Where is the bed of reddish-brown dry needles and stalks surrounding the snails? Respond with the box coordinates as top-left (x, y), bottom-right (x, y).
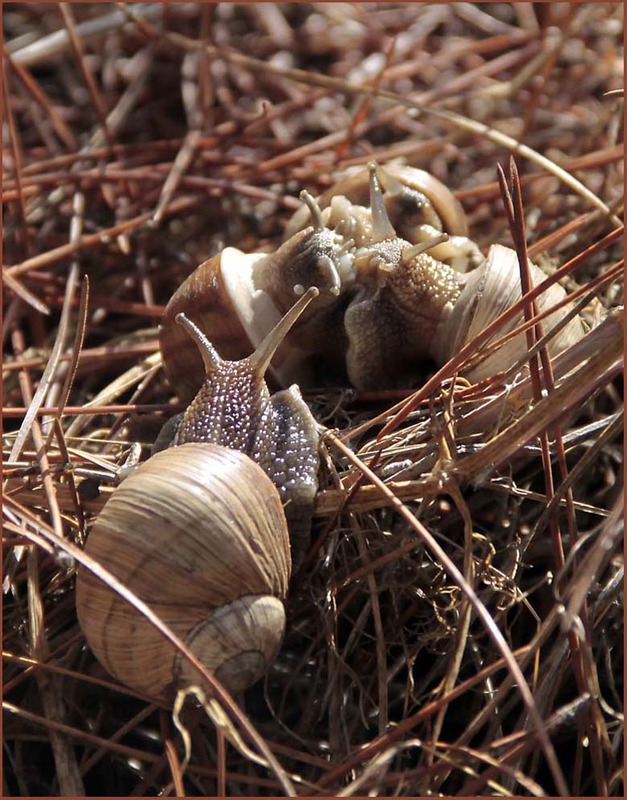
top-left (3, 3), bottom-right (623, 796)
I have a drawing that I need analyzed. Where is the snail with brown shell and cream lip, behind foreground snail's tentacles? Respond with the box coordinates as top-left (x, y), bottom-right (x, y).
top-left (159, 226), bottom-right (350, 401)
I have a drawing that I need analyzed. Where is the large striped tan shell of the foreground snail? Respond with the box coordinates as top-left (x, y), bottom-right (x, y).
top-left (77, 443), bottom-right (291, 697)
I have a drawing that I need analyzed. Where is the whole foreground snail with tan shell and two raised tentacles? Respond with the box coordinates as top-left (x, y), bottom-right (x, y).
top-left (77, 289), bottom-right (319, 698)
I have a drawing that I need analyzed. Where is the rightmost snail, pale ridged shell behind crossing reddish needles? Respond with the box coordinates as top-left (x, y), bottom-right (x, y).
top-left (345, 239), bottom-right (585, 391)
